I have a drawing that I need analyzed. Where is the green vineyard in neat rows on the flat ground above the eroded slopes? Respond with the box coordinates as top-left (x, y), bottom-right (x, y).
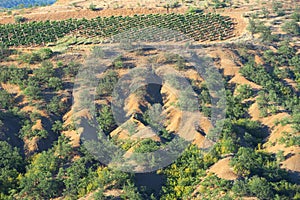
top-left (0, 13), bottom-right (234, 46)
